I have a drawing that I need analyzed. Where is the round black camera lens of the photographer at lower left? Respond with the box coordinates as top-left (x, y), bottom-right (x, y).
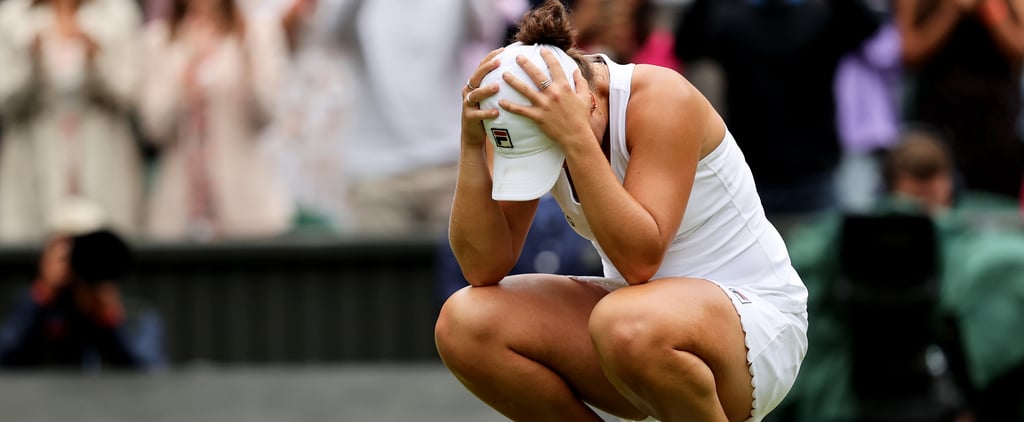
top-left (71, 229), bottom-right (133, 283)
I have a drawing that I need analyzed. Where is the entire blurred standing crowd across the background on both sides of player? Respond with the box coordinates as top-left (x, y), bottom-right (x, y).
top-left (0, 0), bottom-right (1024, 242)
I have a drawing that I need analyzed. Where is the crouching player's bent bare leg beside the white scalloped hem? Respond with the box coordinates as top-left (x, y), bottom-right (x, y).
top-left (590, 279), bottom-right (754, 422)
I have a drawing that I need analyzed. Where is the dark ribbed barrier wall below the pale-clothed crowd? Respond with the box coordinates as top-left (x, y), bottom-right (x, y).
top-left (0, 237), bottom-right (450, 364)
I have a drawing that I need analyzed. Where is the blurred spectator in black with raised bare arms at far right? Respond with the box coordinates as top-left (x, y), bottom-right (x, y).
top-left (894, 0), bottom-right (1024, 199)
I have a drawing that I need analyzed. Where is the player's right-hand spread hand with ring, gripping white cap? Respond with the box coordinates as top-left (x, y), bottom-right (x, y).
top-left (498, 49), bottom-right (594, 147)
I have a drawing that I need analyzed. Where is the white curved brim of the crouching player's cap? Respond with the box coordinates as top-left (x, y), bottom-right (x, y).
top-left (490, 142), bottom-right (565, 201)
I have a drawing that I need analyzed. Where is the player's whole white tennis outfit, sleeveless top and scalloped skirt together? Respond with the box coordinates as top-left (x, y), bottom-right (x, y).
top-left (552, 54), bottom-right (807, 422)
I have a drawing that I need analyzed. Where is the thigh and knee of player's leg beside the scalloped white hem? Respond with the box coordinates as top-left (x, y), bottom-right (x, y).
top-left (592, 278), bottom-right (753, 420)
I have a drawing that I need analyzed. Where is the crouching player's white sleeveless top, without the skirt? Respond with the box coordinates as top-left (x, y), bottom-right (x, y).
top-left (551, 55), bottom-right (807, 312)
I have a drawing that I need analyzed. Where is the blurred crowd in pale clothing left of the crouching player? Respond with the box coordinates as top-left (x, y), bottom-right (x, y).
top-left (0, 0), bottom-right (525, 243)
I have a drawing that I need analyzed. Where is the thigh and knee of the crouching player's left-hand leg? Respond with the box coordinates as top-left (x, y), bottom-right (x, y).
top-left (435, 275), bottom-right (639, 415)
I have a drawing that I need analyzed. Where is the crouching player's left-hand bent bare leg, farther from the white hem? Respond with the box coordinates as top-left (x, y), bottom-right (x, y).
top-left (434, 275), bottom-right (645, 421)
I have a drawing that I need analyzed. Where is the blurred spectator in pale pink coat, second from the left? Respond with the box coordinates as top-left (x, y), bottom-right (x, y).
top-left (140, 0), bottom-right (293, 241)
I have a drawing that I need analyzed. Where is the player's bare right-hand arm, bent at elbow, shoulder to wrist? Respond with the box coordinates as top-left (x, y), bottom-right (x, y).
top-left (566, 66), bottom-right (710, 284)
